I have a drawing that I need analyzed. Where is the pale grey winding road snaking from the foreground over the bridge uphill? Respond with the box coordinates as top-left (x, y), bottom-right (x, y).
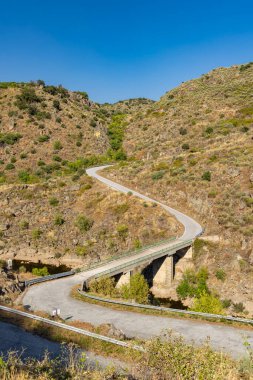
top-left (23, 166), bottom-right (253, 357)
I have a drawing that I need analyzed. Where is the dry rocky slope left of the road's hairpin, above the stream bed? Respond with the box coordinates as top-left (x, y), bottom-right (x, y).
top-left (0, 176), bottom-right (182, 267)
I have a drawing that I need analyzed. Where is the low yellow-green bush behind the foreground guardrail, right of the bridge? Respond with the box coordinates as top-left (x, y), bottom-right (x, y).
top-left (191, 292), bottom-right (223, 314)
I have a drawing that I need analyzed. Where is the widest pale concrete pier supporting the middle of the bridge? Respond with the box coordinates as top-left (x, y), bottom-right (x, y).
top-left (153, 255), bottom-right (174, 288)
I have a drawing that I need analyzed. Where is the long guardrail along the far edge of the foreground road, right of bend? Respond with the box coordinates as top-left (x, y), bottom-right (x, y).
top-left (78, 289), bottom-right (253, 325)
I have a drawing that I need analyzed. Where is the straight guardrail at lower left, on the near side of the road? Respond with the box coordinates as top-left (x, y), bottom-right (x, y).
top-left (0, 305), bottom-right (144, 351)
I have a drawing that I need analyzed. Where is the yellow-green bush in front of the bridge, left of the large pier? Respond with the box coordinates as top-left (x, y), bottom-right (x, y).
top-left (119, 273), bottom-right (149, 304)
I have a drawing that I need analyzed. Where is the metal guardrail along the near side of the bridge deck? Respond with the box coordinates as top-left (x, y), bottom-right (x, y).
top-left (86, 239), bottom-right (192, 284)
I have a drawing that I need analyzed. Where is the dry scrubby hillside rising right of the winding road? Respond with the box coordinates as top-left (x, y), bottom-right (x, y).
top-left (104, 64), bottom-right (253, 311)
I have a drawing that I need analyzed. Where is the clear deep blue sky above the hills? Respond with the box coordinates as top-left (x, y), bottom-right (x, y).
top-left (0, 0), bottom-right (253, 102)
